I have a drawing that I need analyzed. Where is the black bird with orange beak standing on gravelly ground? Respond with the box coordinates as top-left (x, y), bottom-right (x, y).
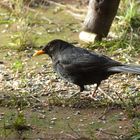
top-left (33, 39), bottom-right (140, 97)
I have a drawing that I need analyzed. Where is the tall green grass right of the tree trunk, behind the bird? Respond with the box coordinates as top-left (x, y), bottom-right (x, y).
top-left (88, 0), bottom-right (140, 59)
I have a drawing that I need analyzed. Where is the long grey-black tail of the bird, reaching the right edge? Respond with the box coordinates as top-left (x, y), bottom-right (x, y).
top-left (107, 65), bottom-right (140, 74)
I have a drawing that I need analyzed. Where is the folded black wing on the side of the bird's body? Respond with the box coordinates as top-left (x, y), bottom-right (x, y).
top-left (58, 47), bottom-right (121, 74)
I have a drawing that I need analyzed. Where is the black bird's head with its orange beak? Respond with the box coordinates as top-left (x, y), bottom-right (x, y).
top-left (33, 39), bottom-right (69, 57)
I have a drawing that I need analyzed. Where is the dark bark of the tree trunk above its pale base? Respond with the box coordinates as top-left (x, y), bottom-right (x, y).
top-left (84, 0), bottom-right (120, 40)
